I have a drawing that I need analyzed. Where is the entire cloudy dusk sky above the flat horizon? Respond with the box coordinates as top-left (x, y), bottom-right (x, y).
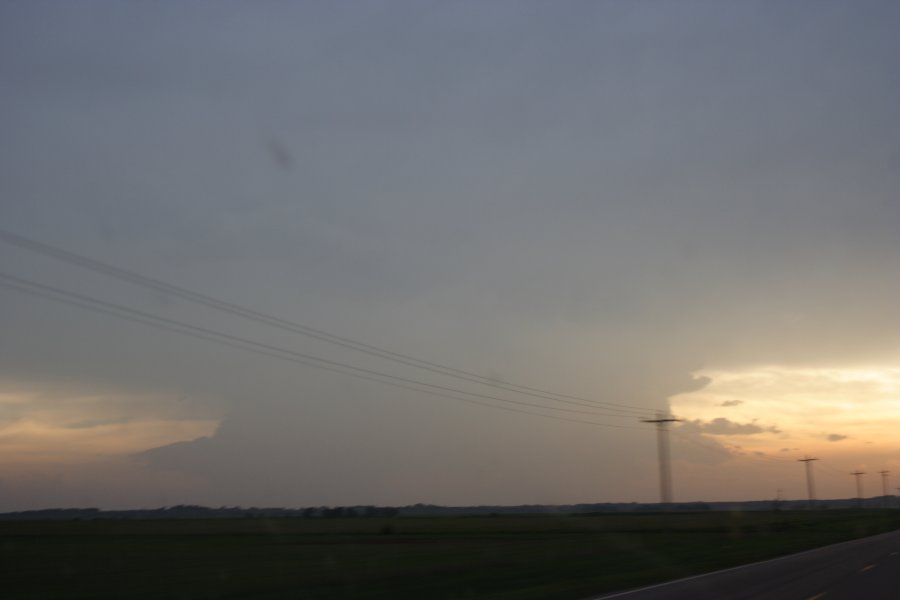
top-left (0, 0), bottom-right (900, 511)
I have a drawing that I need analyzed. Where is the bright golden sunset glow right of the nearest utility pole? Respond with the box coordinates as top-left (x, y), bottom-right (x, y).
top-left (671, 366), bottom-right (900, 460)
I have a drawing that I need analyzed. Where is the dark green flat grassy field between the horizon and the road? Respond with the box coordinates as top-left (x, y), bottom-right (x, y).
top-left (0, 510), bottom-right (900, 600)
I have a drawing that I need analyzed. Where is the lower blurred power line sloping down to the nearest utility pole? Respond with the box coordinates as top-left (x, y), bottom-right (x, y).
top-left (0, 273), bottom-right (640, 429)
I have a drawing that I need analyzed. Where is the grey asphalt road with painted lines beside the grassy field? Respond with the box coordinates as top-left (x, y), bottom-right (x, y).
top-left (596, 531), bottom-right (900, 600)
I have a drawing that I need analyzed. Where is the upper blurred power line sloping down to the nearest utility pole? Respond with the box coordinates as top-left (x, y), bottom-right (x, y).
top-left (0, 230), bottom-right (653, 415)
